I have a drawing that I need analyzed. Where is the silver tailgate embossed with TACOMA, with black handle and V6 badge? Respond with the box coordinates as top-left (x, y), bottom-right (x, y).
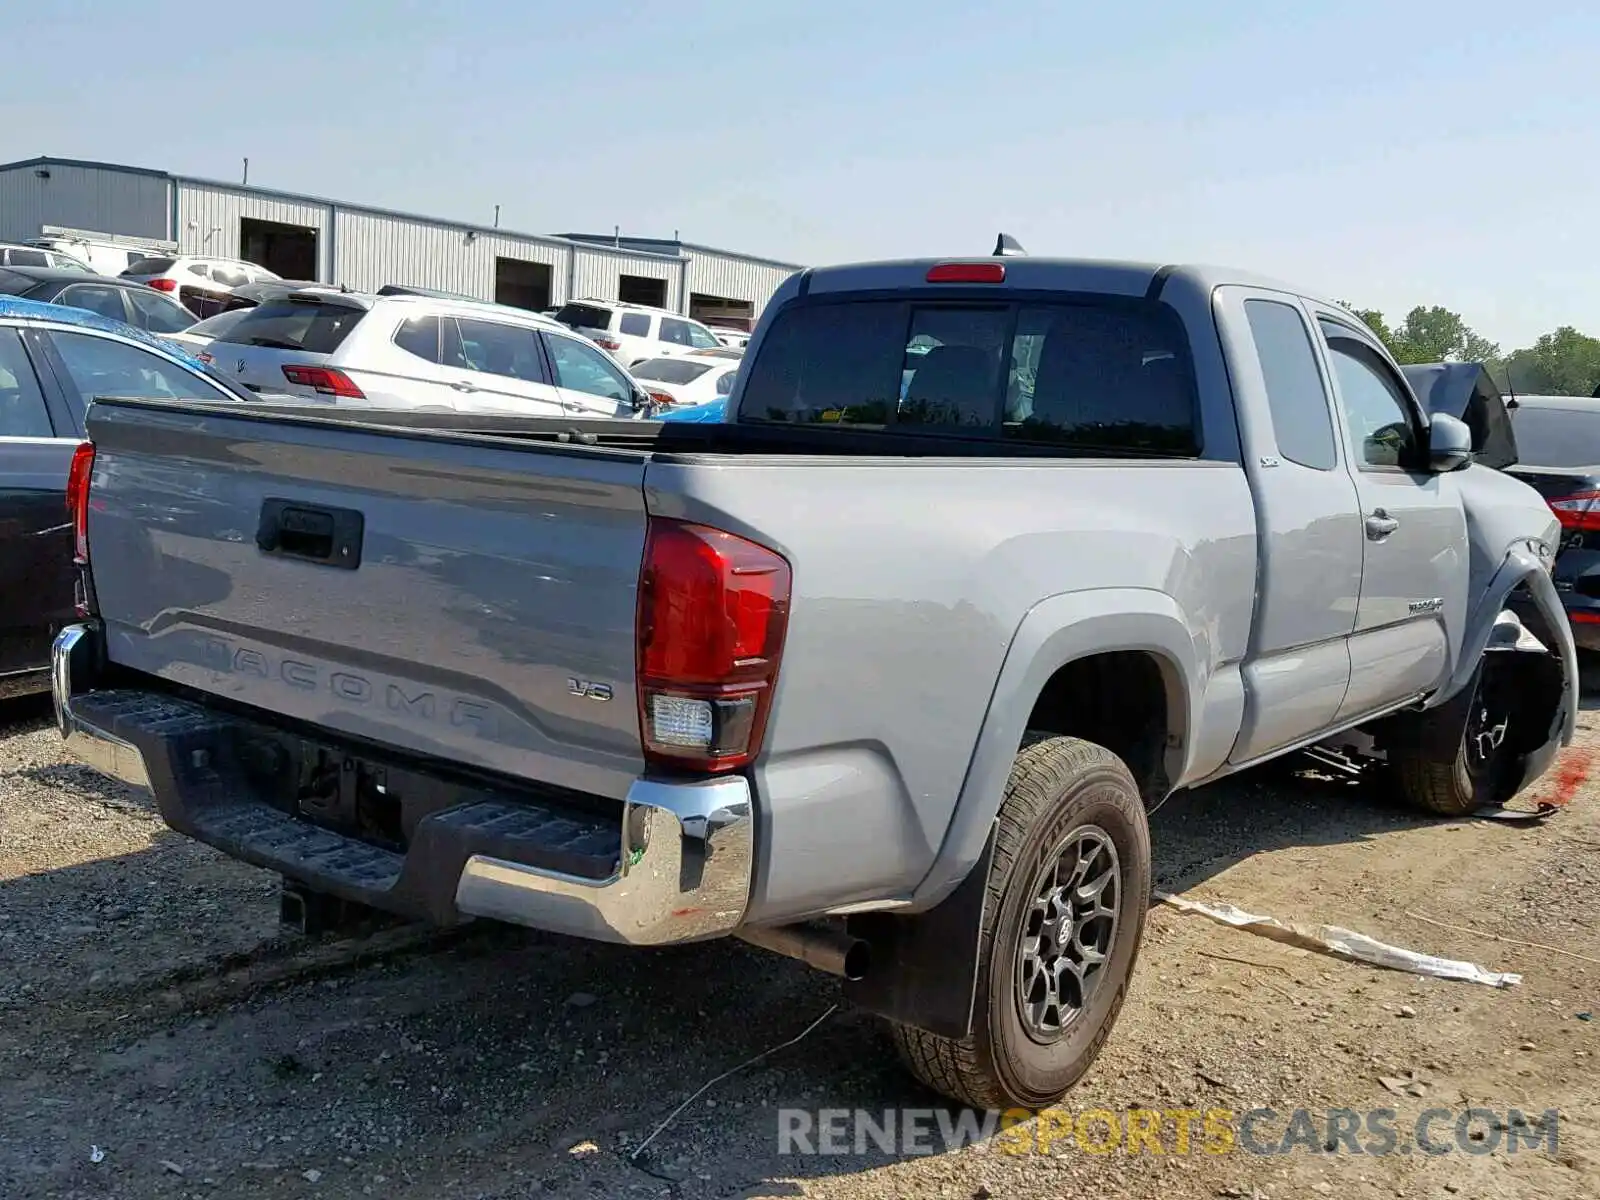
top-left (88, 402), bottom-right (646, 798)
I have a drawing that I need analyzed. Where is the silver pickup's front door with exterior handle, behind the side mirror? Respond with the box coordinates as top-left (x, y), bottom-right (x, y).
top-left (1317, 310), bottom-right (1467, 722)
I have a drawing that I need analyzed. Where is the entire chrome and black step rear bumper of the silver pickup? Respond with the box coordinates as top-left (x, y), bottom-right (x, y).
top-left (51, 624), bottom-right (755, 946)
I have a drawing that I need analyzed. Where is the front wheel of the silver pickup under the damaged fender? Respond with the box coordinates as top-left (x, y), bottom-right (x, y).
top-left (1395, 661), bottom-right (1515, 816)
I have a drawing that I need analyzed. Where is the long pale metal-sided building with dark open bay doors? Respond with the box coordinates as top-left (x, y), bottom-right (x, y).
top-left (0, 158), bottom-right (800, 318)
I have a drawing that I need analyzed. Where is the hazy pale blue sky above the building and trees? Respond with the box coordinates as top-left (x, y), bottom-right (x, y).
top-left (0, 0), bottom-right (1600, 349)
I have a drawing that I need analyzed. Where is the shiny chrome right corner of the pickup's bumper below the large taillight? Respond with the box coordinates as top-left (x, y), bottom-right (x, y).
top-left (456, 776), bottom-right (755, 946)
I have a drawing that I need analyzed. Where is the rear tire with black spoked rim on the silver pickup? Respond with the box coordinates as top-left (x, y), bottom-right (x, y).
top-left (891, 734), bottom-right (1150, 1110)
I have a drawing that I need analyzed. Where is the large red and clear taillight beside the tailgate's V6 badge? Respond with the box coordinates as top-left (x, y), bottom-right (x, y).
top-left (635, 517), bottom-right (790, 771)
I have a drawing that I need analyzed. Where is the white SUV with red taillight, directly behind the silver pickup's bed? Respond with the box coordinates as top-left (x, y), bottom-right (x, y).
top-left (200, 288), bottom-right (650, 418)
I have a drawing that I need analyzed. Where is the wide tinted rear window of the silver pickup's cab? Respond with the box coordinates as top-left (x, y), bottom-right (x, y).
top-left (739, 298), bottom-right (1200, 456)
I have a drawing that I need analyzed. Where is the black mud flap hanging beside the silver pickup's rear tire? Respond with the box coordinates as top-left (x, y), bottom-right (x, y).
top-left (845, 832), bottom-right (994, 1038)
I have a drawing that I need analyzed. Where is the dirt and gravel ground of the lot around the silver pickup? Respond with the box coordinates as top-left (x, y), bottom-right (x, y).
top-left (0, 694), bottom-right (1600, 1200)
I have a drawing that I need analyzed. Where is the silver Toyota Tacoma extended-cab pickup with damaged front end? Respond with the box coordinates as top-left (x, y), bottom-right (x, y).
top-left (54, 256), bottom-right (1576, 1107)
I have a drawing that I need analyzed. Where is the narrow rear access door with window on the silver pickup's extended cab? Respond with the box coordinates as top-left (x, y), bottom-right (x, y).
top-left (1216, 288), bottom-right (1362, 763)
